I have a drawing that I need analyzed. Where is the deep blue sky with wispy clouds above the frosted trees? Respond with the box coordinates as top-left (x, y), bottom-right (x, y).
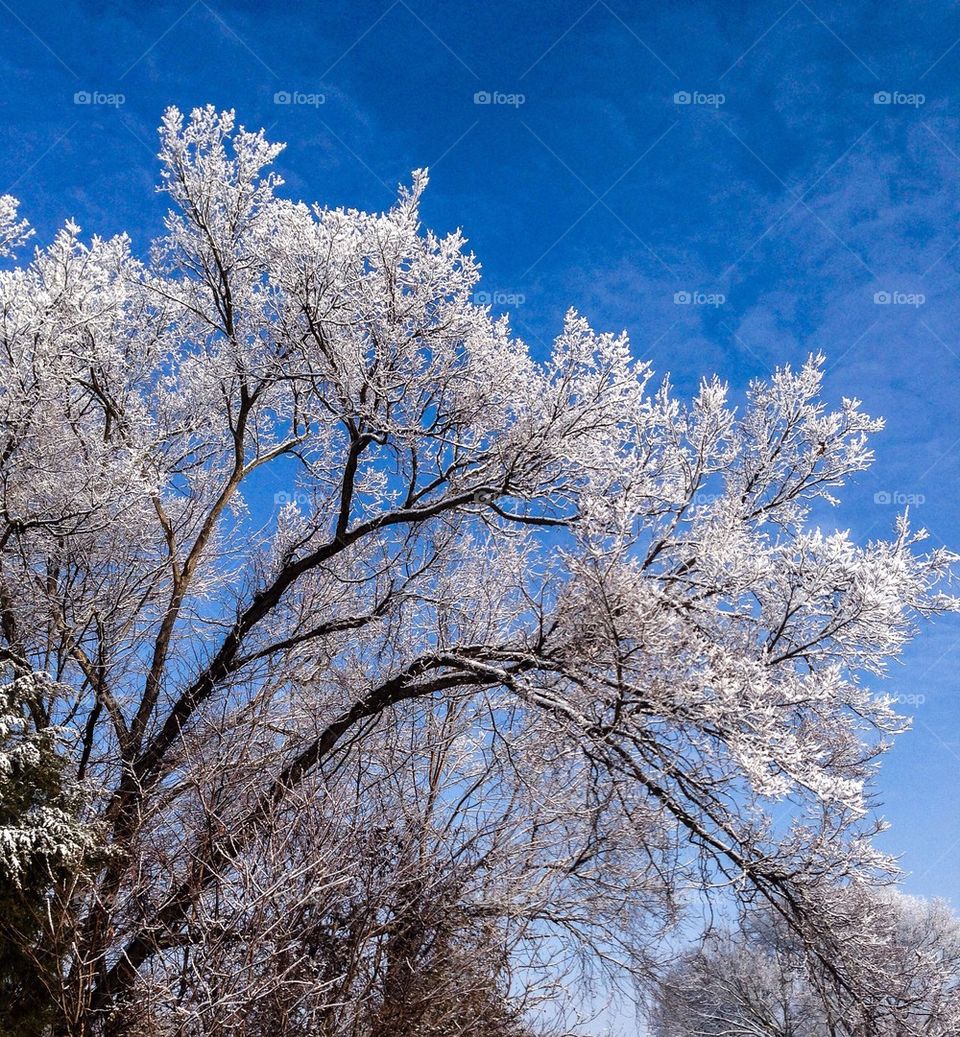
top-left (0, 0), bottom-right (960, 902)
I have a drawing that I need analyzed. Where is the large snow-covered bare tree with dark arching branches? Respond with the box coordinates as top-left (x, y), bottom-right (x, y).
top-left (0, 107), bottom-right (956, 1035)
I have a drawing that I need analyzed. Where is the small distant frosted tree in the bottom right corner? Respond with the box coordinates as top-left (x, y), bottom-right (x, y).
top-left (650, 890), bottom-right (960, 1037)
